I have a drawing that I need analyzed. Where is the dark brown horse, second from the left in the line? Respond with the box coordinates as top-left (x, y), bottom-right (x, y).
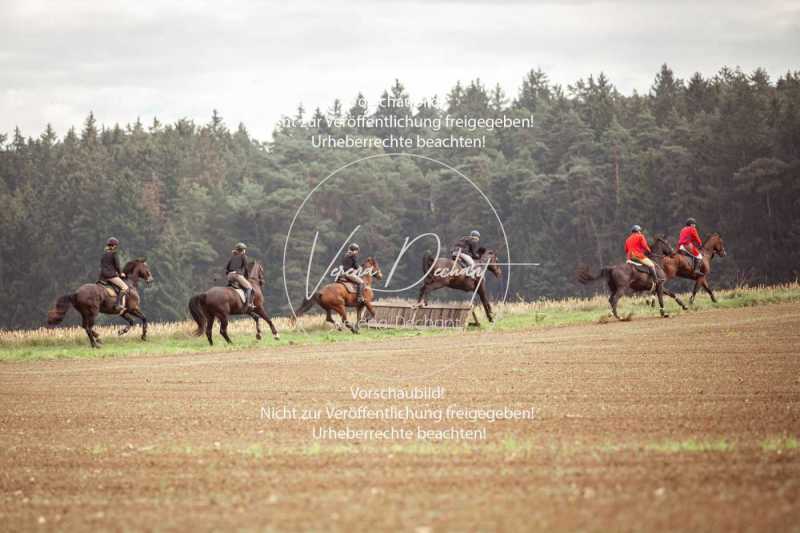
top-left (189, 261), bottom-right (280, 346)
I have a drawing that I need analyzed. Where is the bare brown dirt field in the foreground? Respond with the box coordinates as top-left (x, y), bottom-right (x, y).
top-left (0, 304), bottom-right (800, 531)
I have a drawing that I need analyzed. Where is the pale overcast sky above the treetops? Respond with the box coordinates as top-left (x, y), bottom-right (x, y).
top-left (0, 0), bottom-right (800, 140)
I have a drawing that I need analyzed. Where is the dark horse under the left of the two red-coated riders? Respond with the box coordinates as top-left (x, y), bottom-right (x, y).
top-left (577, 246), bottom-right (686, 320)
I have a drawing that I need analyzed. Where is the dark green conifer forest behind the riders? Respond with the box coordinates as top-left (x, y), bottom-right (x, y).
top-left (0, 65), bottom-right (800, 329)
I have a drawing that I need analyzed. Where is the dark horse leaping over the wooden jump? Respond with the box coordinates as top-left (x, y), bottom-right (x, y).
top-left (417, 247), bottom-right (503, 325)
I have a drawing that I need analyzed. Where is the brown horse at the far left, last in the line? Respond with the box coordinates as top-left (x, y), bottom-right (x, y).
top-left (47, 258), bottom-right (153, 348)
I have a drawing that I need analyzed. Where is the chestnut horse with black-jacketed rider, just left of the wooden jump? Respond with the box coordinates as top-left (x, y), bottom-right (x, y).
top-left (292, 257), bottom-right (383, 333)
